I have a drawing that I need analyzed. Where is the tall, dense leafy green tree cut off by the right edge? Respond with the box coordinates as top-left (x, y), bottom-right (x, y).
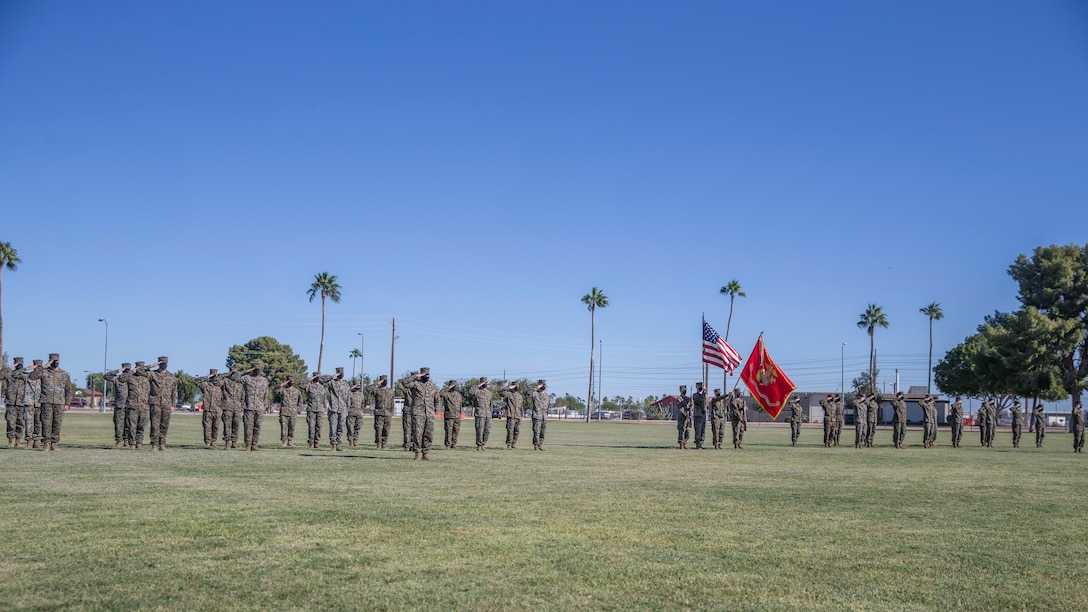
top-left (1009, 244), bottom-right (1088, 404)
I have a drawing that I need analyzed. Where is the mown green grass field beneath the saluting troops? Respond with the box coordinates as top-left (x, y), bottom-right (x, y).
top-left (0, 414), bottom-right (1088, 610)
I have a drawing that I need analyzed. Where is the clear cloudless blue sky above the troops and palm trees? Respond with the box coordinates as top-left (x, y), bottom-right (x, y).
top-left (0, 1), bottom-right (1088, 405)
